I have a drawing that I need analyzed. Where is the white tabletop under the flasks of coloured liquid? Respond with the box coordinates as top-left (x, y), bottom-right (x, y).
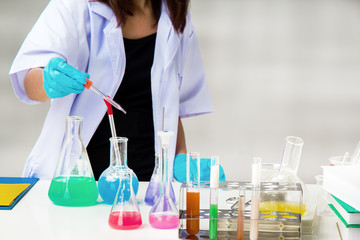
top-left (0, 181), bottom-right (340, 240)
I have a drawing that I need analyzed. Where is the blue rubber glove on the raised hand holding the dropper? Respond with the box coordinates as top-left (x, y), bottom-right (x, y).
top-left (43, 58), bottom-right (90, 98)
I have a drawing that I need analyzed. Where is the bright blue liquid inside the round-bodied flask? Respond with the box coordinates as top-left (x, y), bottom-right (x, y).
top-left (98, 174), bottom-right (139, 205)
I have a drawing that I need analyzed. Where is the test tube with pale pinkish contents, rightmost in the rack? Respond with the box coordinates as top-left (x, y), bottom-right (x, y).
top-left (250, 157), bottom-right (261, 240)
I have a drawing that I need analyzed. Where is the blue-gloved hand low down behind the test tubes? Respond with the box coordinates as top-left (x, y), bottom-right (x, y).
top-left (173, 154), bottom-right (226, 182)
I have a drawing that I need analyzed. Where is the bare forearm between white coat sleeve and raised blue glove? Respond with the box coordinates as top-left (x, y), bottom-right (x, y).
top-left (24, 68), bottom-right (50, 102)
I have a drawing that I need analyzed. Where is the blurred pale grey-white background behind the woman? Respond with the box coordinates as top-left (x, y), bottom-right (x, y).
top-left (0, 0), bottom-right (360, 183)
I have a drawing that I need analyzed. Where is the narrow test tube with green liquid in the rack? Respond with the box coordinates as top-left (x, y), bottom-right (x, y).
top-left (209, 156), bottom-right (219, 239)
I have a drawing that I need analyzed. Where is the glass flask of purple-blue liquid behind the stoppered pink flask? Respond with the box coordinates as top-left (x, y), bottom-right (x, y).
top-left (145, 154), bottom-right (176, 206)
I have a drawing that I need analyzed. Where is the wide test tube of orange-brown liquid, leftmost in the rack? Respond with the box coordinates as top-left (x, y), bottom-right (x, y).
top-left (186, 152), bottom-right (200, 235)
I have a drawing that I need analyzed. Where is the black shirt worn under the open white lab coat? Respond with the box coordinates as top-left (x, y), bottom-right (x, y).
top-left (87, 33), bottom-right (156, 181)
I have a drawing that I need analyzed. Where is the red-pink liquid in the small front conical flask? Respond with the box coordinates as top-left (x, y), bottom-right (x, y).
top-left (109, 211), bottom-right (142, 230)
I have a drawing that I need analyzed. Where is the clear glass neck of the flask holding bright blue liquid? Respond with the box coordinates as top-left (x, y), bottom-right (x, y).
top-left (110, 137), bottom-right (128, 168)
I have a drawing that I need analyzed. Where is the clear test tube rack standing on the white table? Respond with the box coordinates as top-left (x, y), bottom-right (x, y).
top-left (178, 181), bottom-right (306, 240)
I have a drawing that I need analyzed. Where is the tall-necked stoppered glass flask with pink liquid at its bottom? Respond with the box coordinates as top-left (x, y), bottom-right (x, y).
top-left (149, 131), bottom-right (179, 229)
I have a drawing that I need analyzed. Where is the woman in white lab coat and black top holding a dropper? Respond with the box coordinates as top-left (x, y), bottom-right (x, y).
top-left (10, 0), bottom-right (213, 180)
